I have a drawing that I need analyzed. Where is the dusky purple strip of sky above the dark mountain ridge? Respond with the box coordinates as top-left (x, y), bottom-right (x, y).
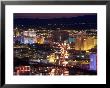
top-left (14, 13), bottom-right (96, 19)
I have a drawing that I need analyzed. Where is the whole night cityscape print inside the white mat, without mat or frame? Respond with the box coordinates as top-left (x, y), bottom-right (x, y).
top-left (13, 13), bottom-right (97, 76)
